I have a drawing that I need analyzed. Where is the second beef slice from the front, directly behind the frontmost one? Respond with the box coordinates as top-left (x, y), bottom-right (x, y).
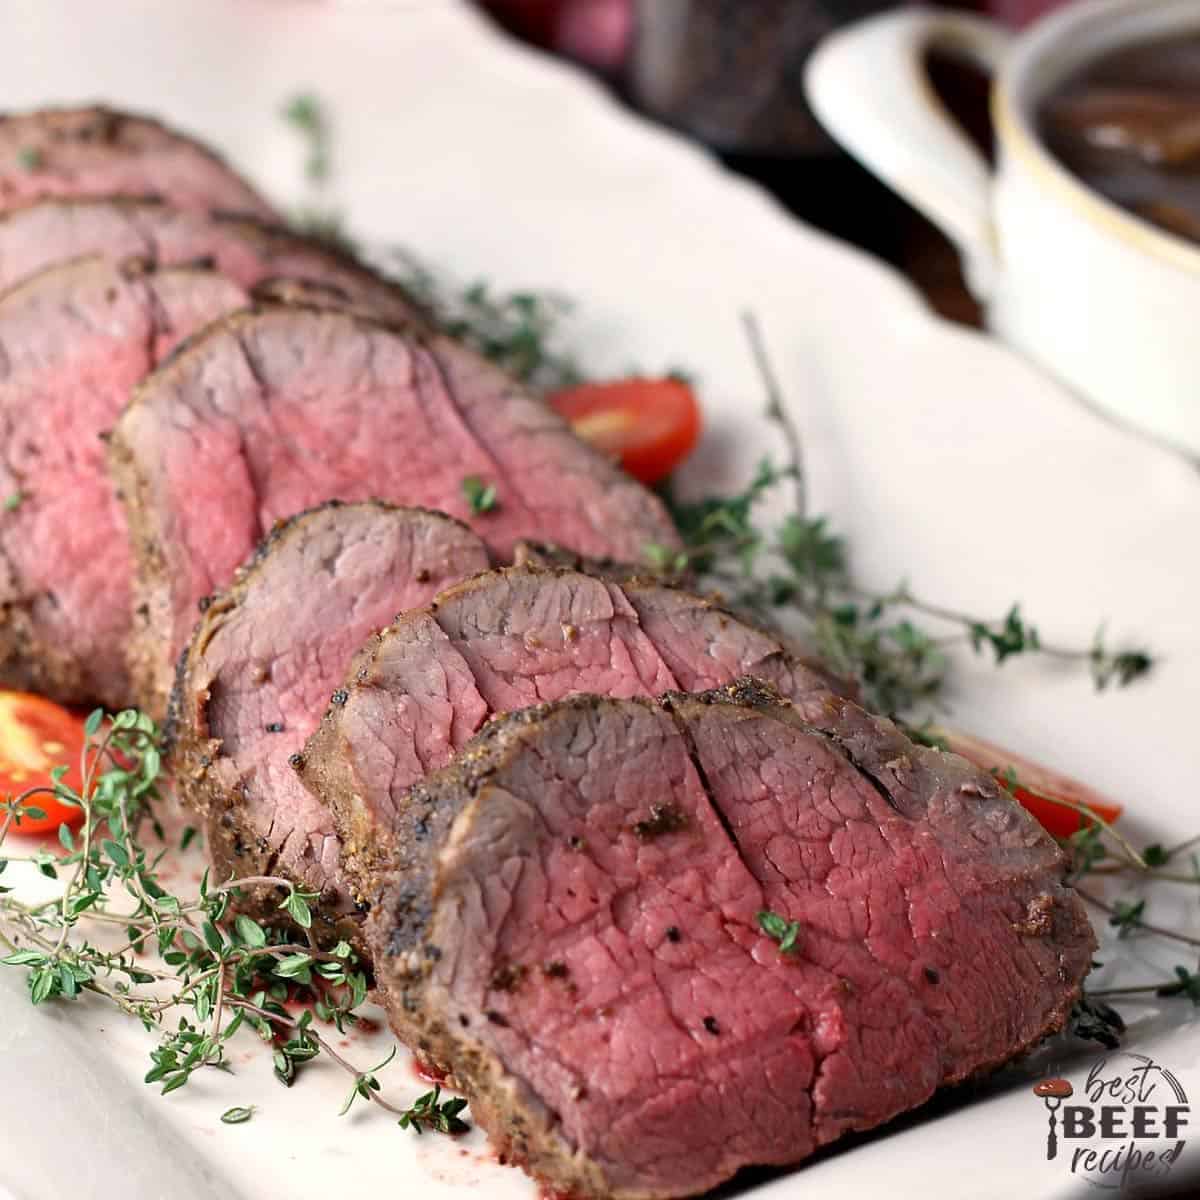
top-left (301, 566), bottom-right (844, 901)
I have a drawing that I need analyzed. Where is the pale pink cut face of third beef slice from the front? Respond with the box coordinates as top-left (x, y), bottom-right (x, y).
top-left (186, 504), bottom-right (487, 902)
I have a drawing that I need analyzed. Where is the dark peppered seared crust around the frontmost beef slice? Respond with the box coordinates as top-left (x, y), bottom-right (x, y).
top-left (366, 679), bottom-right (1094, 1200)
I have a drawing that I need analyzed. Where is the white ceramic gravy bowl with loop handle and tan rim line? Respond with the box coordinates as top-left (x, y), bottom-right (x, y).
top-left (806, 0), bottom-right (1200, 456)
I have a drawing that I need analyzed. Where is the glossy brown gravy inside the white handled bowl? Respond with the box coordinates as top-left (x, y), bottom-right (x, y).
top-left (1038, 32), bottom-right (1200, 245)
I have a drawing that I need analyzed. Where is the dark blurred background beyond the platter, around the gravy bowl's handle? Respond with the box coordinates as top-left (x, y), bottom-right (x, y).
top-left (479, 0), bottom-right (1063, 324)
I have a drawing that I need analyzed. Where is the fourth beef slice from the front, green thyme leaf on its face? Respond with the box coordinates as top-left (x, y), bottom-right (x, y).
top-left (112, 306), bottom-right (677, 709)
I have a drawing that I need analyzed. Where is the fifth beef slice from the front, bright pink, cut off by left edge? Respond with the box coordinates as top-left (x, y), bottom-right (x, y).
top-left (0, 259), bottom-right (246, 707)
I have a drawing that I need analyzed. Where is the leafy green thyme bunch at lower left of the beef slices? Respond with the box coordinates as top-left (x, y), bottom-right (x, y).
top-left (0, 710), bottom-right (462, 1126)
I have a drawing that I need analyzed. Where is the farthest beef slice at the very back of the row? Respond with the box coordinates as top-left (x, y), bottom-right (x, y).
top-left (0, 107), bottom-right (275, 220)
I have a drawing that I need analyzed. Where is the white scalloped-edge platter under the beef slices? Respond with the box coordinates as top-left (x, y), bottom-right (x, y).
top-left (0, 0), bottom-right (1200, 1200)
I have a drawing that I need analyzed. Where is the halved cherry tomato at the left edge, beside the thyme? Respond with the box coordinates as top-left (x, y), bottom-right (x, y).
top-left (0, 691), bottom-right (86, 834)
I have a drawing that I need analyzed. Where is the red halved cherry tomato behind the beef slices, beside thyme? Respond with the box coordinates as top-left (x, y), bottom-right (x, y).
top-left (550, 379), bottom-right (701, 484)
